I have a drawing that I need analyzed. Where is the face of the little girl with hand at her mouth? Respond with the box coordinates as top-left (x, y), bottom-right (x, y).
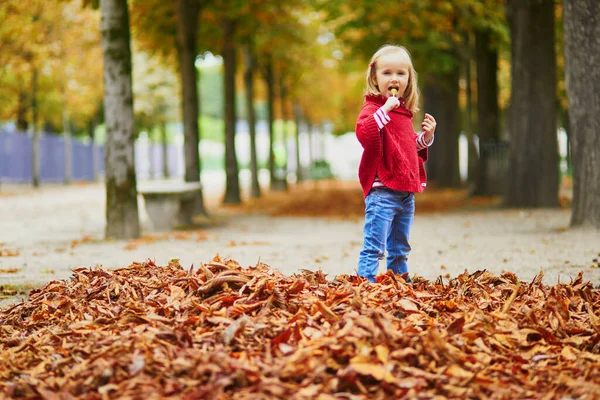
top-left (375, 51), bottom-right (410, 97)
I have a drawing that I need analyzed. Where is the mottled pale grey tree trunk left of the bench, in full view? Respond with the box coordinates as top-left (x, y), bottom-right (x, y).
top-left (100, 0), bottom-right (140, 239)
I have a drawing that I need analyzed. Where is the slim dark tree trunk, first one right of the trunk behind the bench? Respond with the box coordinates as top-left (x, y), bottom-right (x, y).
top-left (222, 18), bottom-right (242, 204)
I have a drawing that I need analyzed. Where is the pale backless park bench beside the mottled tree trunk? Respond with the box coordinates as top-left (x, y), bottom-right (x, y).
top-left (138, 181), bottom-right (202, 231)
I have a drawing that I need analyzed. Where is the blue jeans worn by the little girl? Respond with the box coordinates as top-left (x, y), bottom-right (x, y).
top-left (358, 188), bottom-right (415, 282)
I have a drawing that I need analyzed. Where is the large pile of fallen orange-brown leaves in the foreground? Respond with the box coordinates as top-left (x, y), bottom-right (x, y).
top-left (0, 257), bottom-right (600, 400)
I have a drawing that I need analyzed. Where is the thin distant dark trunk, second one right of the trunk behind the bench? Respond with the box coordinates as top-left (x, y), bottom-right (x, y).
top-left (244, 39), bottom-right (260, 198)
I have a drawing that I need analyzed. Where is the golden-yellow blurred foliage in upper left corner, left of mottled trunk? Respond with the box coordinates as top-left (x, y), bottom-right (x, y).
top-left (0, 0), bottom-right (103, 134)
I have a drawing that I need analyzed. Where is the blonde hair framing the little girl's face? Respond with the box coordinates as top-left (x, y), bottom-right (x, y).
top-left (365, 44), bottom-right (419, 113)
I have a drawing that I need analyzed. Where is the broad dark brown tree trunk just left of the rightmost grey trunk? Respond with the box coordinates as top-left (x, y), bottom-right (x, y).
top-left (504, 0), bottom-right (558, 207)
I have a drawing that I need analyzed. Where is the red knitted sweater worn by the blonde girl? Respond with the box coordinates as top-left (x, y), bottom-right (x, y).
top-left (356, 95), bottom-right (427, 197)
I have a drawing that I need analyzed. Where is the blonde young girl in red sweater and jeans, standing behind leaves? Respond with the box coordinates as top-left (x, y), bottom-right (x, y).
top-left (356, 45), bottom-right (436, 282)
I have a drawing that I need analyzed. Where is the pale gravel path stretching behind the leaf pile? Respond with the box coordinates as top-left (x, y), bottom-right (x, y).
top-left (0, 183), bottom-right (600, 305)
